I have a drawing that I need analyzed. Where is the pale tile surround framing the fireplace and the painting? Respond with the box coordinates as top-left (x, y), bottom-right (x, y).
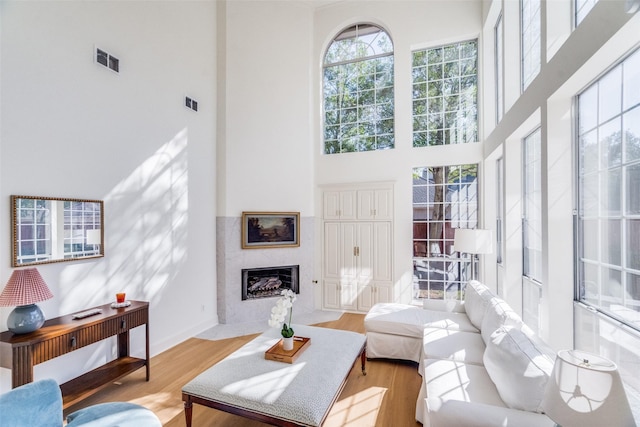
top-left (216, 217), bottom-right (315, 325)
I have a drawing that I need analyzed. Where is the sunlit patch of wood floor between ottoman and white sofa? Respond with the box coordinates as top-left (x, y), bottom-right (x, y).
top-left (323, 387), bottom-right (387, 427)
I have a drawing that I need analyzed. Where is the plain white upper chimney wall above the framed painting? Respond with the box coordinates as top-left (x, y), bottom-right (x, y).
top-left (217, 1), bottom-right (313, 217)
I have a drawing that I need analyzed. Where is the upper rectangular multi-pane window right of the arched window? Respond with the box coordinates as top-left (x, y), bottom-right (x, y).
top-left (413, 40), bottom-right (478, 147)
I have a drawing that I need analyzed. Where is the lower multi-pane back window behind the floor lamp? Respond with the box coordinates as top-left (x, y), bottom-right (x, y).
top-left (413, 164), bottom-right (478, 299)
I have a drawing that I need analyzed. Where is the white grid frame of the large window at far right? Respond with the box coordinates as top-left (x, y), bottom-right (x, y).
top-left (574, 48), bottom-right (640, 331)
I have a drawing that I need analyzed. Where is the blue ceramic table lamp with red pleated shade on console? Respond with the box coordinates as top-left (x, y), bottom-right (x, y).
top-left (0, 268), bottom-right (53, 334)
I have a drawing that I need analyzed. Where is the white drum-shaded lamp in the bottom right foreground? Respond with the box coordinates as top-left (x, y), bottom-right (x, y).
top-left (542, 350), bottom-right (636, 427)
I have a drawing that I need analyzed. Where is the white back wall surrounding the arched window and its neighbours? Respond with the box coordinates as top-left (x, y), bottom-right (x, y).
top-left (312, 0), bottom-right (482, 302)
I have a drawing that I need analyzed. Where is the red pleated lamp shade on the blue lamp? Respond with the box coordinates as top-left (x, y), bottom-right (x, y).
top-left (0, 268), bottom-right (53, 307)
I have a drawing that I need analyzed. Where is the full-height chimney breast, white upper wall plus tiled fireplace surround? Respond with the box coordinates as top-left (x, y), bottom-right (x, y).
top-left (216, 1), bottom-right (319, 325)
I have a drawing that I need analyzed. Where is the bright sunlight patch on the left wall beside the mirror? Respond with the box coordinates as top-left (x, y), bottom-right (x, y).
top-left (61, 128), bottom-right (189, 311)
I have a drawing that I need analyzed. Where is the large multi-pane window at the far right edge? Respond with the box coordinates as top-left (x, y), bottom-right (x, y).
top-left (577, 46), bottom-right (640, 322)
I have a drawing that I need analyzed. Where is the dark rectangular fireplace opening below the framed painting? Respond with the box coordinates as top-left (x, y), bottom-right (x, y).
top-left (242, 265), bottom-right (300, 301)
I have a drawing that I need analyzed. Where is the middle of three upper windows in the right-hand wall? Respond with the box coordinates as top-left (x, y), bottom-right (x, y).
top-left (520, 0), bottom-right (541, 91)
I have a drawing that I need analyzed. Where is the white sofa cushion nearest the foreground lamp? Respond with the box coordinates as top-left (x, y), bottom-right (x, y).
top-left (483, 326), bottom-right (553, 412)
